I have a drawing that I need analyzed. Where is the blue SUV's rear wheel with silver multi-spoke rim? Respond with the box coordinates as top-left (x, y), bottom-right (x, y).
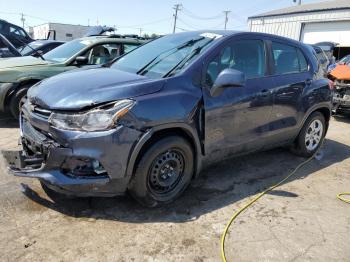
top-left (293, 112), bottom-right (326, 157)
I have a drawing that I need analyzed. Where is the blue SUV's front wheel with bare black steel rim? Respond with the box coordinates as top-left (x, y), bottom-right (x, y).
top-left (129, 136), bottom-right (194, 207)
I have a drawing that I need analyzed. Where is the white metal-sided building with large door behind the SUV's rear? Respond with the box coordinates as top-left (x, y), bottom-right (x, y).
top-left (248, 0), bottom-right (350, 46)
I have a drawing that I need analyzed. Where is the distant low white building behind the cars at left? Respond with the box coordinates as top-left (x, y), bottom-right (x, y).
top-left (32, 23), bottom-right (90, 41)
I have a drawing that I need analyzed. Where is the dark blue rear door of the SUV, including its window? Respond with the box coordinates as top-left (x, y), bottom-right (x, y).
top-left (270, 41), bottom-right (313, 140)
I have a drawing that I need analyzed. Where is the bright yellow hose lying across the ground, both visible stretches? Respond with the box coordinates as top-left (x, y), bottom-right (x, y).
top-left (220, 145), bottom-right (350, 262)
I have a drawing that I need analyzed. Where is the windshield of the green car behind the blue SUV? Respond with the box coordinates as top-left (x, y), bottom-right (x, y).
top-left (44, 39), bottom-right (92, 63)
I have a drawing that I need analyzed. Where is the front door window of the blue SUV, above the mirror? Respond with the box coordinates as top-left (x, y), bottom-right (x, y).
top-left (205, 40), bottom-right (266, 87)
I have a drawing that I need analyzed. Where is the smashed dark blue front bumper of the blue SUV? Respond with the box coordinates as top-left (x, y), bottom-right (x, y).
top-left (3, 104), bottom-right (142, 196)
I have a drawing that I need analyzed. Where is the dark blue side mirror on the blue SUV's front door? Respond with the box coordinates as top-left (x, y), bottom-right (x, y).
top-left (210, 68), bottom-right (245, 97)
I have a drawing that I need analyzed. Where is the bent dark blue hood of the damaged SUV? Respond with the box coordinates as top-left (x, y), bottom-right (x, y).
top-left (28, 68), bottom-right (164, 110)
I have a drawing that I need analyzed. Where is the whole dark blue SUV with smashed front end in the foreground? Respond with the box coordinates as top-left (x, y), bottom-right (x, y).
top-left (6, 31), bottom-right (332, 206)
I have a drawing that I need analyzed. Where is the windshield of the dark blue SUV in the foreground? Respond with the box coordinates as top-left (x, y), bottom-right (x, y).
top-left (112, 32), bottom-right (221, 78)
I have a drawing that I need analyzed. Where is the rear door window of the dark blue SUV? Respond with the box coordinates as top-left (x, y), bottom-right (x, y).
top-left (272, 42), bottom-right (308, 75)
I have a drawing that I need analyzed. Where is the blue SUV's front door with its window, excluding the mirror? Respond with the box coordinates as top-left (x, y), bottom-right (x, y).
top-left (203, 36), bottom-right (273, 157)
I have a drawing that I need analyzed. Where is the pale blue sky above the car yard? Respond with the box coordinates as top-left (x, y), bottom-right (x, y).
top-left (0, 0), bottom-right (320, 34)
